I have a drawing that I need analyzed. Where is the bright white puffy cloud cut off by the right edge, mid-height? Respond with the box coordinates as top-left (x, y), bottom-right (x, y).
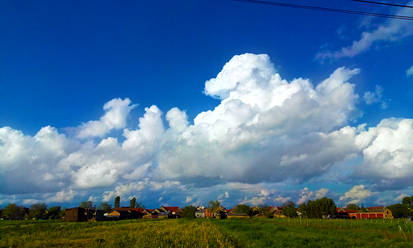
top-left (356, 119), bottom-right (413, 187)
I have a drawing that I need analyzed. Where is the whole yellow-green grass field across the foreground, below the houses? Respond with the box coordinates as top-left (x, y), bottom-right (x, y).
top-left (0, 219), bottom-right (413, 248)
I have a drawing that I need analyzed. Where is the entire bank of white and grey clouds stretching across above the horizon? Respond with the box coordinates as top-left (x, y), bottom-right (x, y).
top-left (0, 54), bottom-right (413, 207)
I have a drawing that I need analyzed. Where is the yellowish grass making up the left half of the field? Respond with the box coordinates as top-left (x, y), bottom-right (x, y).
top-left (0, 220), bottom-right (234, 247)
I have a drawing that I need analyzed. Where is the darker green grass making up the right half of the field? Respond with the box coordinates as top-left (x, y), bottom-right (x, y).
top-left (216, 219), bottom-right (413, 247)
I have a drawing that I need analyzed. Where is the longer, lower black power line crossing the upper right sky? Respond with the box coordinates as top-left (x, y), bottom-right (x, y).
top-left (233, 0), bottom-right (413, 21)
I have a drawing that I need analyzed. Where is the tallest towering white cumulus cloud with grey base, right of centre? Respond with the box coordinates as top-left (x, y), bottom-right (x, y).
top-left (158, 54), bottom-right (358, 183)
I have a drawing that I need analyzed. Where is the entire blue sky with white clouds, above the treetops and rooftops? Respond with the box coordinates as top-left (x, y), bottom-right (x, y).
top-left (0, 0), bottom-right (413, 206)
